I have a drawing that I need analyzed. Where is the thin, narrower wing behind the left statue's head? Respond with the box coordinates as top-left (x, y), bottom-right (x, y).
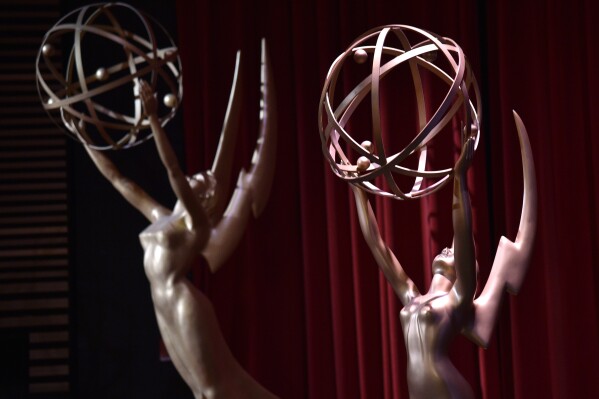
top-left (211, 51), bottom-right (243, 220)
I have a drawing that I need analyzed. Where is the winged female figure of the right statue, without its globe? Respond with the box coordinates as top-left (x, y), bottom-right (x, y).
top-left (352, 112), bottom-right (537, 399)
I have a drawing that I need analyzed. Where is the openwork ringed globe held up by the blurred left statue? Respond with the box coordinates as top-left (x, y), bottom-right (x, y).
top-left (36, 3), bottom-right (183, 150)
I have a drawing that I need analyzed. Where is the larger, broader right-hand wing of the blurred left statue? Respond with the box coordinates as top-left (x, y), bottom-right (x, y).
top-left (202, 39), bottom-right (277, 272)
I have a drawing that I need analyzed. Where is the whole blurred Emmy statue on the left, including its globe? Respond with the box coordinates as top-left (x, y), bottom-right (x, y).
top-left (37, 3), bottom-right (277, 399)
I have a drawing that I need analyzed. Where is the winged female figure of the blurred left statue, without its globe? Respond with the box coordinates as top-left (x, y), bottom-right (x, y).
top-left (70, 41), bottom-right (276, 399)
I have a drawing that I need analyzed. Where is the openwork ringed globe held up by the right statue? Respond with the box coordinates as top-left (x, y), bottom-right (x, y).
top-left (318, 25), bottom-right (481, 200)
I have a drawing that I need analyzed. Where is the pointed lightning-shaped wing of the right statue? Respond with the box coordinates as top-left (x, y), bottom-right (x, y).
top-left (462, 111), bottom-right (537, 348)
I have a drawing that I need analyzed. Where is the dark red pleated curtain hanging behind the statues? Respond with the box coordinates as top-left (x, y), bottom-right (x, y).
top-left (177, 0), bottom-right (599, 399)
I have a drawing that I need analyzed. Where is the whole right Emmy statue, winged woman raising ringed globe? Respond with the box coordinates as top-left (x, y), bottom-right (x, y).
top-left (326, 25), bottom-right (537, 399)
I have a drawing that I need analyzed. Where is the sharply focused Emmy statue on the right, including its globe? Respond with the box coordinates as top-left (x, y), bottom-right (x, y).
top-left (318, 25), bottom-right (536, 399)
